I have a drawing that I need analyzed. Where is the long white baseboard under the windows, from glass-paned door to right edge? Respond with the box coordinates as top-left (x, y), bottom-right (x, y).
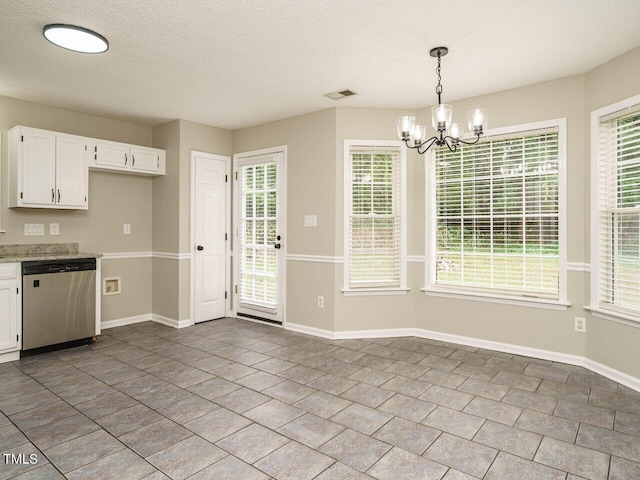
top-left (284, 323), bottom-right (640, 392)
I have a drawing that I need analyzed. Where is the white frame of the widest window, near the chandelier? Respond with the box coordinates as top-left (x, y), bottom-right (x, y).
top-left (421, 118), bottom-right (570, 309)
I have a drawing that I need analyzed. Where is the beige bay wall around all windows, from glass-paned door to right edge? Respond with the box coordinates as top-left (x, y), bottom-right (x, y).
top-left (233, 49), bottom-right (640, 377)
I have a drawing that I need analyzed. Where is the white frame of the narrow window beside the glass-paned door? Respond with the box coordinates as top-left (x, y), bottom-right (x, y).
top-left (342, 140), bottom-right (409, 296)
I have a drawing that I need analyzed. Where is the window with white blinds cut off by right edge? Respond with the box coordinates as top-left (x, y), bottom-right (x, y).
top-left (592, 97), bottom-right (640, 317)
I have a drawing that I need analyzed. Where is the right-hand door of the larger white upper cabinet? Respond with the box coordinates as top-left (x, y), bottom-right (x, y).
top-left (56, 135), bottom-right (89, 208)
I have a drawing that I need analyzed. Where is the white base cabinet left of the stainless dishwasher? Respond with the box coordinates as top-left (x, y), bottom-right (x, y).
top-left (0, 263), bottom-right (21, 361)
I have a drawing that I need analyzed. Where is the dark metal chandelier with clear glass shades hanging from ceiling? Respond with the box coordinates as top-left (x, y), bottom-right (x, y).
top-left (397, 47), bottom-right (487, 154)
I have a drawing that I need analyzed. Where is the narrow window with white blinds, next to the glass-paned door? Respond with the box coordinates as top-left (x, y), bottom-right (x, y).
top-left (345, 140), bottom-right (406, 292)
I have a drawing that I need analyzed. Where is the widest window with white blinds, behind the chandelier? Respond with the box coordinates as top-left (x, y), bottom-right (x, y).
top-left (426, 120), bottom-right (566, 301)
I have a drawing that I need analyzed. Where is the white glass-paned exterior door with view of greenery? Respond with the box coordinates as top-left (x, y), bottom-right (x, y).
top-left (235, 147), bottom-right (286, 324)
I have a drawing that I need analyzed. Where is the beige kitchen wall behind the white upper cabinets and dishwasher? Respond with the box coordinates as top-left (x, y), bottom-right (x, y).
top-left (0, 97), bottom-right (152, 321)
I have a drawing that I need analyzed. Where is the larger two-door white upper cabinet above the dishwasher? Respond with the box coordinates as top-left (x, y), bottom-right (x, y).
top-left (9, 127), bottom-right (89, 210)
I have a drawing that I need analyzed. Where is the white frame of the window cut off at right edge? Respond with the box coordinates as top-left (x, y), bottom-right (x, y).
top-left (585, 95), bottom-right (640, 326)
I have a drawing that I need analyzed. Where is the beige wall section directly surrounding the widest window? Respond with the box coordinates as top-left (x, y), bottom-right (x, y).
top-left (412, 76), bottom-right (588, 355)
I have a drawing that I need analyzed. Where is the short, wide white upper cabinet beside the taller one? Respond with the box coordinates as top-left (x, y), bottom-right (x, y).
top-left (94, 140), bottom-right (165, 175)
